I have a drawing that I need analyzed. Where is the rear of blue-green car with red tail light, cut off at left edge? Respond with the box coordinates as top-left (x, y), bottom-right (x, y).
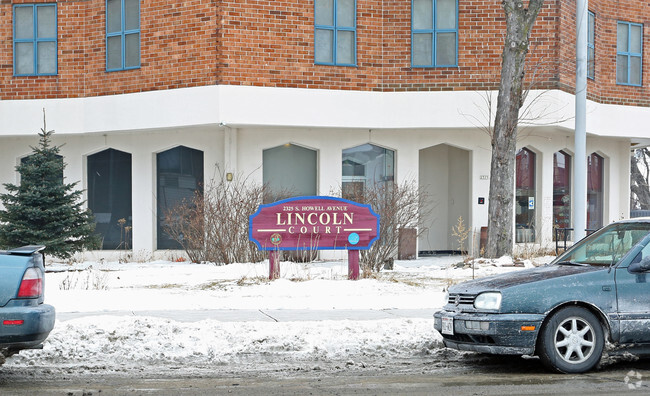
top-left (0, 246), bottom-right (55, 364)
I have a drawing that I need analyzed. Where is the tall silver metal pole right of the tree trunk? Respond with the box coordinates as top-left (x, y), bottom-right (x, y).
top-left (573, 0), bottom-right (589, 242)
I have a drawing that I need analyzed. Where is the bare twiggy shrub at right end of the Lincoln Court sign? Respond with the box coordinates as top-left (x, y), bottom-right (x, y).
top-left (340, 180), bottom-right (432, 277)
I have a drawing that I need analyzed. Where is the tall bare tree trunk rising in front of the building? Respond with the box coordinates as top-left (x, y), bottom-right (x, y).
top-left (485, 0), bottom-right (544, 257)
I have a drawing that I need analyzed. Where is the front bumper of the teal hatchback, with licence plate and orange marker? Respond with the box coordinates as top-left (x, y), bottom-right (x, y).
top-left (434, 310), bottom-right (544, 355)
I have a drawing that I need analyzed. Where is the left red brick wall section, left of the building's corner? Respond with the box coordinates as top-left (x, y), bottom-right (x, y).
top-left (0, 0), bottom-right (217, 100)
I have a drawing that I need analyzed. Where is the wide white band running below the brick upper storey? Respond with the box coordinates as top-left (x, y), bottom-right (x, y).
top-left (0, 85), bottom-right (650, 142)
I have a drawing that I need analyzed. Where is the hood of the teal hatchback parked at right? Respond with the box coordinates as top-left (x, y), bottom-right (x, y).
top-left (449, 265), bottom-right (603, 294)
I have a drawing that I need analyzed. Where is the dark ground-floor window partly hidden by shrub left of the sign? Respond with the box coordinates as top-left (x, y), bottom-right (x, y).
top-left (156, 146), bottom-right (203, 249)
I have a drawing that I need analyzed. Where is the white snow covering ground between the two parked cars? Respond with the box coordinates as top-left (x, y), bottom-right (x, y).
top-left (6, 256), bottom-right (549, 372)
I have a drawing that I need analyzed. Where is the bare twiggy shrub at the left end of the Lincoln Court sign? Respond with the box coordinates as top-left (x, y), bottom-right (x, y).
top-left (165, 172), bottom-right (265, 264)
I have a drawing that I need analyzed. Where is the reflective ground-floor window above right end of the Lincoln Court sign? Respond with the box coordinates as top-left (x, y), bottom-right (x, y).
top-left (342, 144), bottom-right (395, 201)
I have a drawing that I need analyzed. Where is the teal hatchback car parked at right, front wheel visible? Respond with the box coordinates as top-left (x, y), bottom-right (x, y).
top-left (434, 218), bottom-right (650, 373)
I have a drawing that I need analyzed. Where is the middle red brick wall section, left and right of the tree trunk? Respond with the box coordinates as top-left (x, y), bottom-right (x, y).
top-left (220, 0), bottom-right (559, 91)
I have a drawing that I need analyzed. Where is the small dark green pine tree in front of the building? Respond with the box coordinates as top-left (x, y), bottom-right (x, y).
top-left (0, 112), bottom-right (100, 259)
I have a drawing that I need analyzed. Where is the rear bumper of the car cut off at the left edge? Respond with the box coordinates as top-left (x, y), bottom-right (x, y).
top-left (0, 304), bottom-right (56, 350)
